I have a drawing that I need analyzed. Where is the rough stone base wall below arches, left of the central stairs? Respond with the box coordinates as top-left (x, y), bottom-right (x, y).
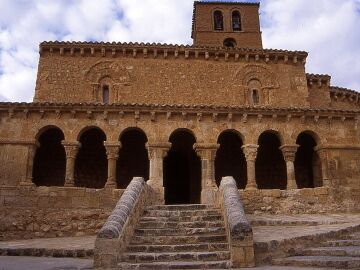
top-left (0, 187), bottom-right (123, 240)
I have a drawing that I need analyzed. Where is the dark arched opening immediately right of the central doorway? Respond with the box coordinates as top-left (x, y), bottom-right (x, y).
top-left (215, 129), bottom-right (247, 189)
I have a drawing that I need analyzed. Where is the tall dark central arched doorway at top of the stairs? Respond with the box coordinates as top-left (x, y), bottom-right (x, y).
top-left (164, 128), bottom-right (201, 204)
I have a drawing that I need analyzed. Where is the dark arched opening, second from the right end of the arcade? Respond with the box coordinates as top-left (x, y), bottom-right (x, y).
top-left (255, 130), bottom-right (287, 189)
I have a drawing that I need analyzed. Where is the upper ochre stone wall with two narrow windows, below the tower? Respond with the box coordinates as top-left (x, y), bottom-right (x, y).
top-left (34, 47), bottom-right (309, 107)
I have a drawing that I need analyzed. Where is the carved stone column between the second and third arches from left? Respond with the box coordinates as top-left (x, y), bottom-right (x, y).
top-left (104, 142), bottom-right (121, 188)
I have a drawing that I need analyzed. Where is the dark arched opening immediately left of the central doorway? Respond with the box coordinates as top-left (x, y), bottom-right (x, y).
top-left (116, 127), bottom-right (149, 188)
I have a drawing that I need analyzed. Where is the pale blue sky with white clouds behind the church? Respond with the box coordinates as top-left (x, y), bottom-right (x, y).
top-left (0, 0), bottom-right (360, 101)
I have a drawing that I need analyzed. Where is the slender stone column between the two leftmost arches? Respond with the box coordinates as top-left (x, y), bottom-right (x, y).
top-left (61, 141), bottom-right (81, 187)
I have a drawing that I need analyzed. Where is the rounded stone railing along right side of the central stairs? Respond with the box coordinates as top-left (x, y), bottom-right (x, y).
top-left (219, 176), bottom-right (255, 267)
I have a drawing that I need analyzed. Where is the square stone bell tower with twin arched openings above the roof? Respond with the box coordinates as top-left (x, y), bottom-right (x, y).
top-left (191, 1), bottom-right (262, 49)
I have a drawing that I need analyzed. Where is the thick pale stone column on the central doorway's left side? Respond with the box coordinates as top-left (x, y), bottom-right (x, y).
top-left (146, 142), bottom-right (171, 204)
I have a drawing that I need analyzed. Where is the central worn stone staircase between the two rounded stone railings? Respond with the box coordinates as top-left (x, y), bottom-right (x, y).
top-left (118, 204), bottom-right (231, 269)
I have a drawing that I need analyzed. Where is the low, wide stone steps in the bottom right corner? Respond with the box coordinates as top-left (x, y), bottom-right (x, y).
top-left (273, 232), bottom-right (360, 269)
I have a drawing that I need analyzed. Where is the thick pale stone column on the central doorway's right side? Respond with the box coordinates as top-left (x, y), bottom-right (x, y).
top-left (194, 143), bottom-right (220, 204)
